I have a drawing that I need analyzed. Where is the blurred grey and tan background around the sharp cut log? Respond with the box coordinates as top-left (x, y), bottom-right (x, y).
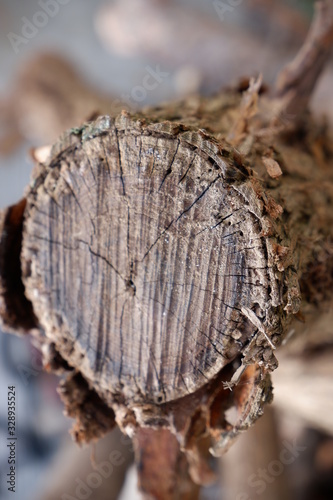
top-left (0, 0), bottom-right (333, 500)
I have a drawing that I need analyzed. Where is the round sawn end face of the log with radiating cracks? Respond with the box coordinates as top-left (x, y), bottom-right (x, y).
top-left (22, 115), bottom-right (280, 403)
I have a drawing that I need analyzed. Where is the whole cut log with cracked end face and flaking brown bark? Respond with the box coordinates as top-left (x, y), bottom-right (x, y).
top-left (0, 1), bottom-right (333, 500)
